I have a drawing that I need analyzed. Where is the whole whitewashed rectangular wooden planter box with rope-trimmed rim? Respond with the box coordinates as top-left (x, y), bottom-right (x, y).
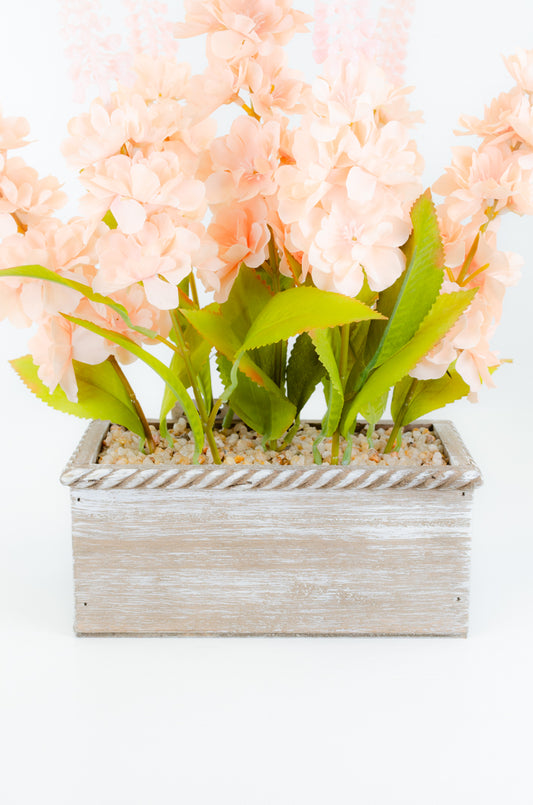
top-left (61, 422), bottom-right (481, 636)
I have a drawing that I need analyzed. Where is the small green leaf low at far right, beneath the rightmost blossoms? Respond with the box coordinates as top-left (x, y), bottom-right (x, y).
top-left (391, 366), bottom-right (470, 427)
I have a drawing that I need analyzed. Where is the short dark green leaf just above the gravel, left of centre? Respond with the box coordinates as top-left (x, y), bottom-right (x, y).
top-left (217, 355), bottom-right (296, 441)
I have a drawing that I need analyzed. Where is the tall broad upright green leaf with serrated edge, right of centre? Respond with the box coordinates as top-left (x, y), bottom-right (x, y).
top-left (361, 190), bottom-right (444, 376)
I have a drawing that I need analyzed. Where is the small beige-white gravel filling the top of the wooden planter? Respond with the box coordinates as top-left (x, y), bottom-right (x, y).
top-left (98, 418), bottom-right (447, 467)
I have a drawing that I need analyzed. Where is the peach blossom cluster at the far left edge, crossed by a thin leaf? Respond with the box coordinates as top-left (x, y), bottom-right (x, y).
top-left (0, 110), bottom-right (170, 401)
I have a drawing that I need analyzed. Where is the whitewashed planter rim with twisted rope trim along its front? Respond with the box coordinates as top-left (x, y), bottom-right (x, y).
top-left (61, 420), bottom-right (482, 491)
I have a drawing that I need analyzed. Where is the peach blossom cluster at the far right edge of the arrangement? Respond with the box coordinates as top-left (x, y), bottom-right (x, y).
top-left (412, 50), bottom-right (533, 393)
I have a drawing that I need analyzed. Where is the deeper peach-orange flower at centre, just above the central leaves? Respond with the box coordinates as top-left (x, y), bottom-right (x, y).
top-left (202, 198), bottom-right (270, 302)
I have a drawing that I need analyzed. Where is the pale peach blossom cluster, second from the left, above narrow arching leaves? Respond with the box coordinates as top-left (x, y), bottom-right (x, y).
top-left (64, 57), bottom-right (220, 310)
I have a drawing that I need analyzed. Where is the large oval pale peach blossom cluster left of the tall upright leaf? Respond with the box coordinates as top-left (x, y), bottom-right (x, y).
top-left (277, 59), bottom-right (423, 296)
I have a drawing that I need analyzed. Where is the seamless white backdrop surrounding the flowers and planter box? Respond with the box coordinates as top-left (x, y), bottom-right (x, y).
top-left (0, 0), bottom-right (533, 805)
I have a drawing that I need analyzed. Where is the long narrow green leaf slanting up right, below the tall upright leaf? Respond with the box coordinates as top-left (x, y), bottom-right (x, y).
top-left (342, 288), bottom-right (476, 434)
